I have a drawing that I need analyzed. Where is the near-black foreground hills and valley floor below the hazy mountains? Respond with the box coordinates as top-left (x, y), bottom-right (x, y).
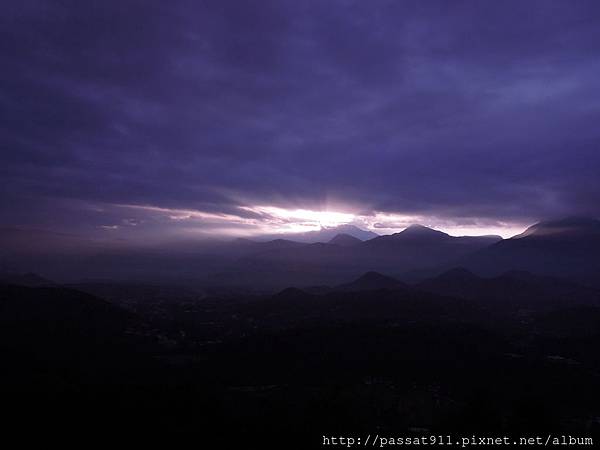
top-left (0, 273), bottom-right (600, 442)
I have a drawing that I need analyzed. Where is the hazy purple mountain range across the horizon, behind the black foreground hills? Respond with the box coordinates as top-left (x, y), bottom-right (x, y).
top-left (0, 217), bottom-right (600, 292)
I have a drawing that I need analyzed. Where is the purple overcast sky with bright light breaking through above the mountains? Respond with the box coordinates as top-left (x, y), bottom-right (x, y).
top-left (0, 0), bottom-right (600, 241)
